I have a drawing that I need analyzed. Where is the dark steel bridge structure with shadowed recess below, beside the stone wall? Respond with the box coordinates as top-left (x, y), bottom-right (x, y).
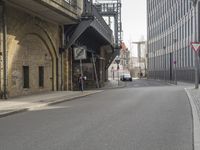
top-left (64, 0), bottom-right (120, 89)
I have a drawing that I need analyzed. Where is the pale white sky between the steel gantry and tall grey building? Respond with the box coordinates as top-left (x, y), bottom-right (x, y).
top-left (122, 0), bottom-right (147, 56)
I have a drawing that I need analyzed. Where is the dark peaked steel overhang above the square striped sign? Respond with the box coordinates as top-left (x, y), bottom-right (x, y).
top-left (65, 19), bottom-right (114, 49)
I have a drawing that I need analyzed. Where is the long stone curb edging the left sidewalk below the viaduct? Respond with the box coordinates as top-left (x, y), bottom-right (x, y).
top-left (0, 90), bottom-right (103, 118)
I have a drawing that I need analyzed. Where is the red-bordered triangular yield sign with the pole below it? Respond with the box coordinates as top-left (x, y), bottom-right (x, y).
top-left (191, 42), bottom-right (200, 89)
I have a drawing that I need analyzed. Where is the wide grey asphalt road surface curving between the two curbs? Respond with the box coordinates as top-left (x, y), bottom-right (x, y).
top-left (0, 80), bottom-right (193, 150)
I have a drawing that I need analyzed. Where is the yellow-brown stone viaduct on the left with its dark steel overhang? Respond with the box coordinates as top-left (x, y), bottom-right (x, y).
top-left (0, 0), bottom-right (114, 98)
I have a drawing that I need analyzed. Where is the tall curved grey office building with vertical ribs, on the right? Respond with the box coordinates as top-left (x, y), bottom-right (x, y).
top-left (147, 0), bottom-right (197, 82)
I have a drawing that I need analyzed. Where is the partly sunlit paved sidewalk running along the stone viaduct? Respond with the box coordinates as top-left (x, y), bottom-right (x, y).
top-left (0, 80), bottom-right (124, 118)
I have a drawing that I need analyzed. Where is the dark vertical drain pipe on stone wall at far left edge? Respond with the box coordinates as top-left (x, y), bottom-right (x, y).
top-left (1, 1), bottom-right (8, 99)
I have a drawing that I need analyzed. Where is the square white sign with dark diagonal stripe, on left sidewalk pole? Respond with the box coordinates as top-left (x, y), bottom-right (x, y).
top-left (74, 46), bottom-right (87, 60)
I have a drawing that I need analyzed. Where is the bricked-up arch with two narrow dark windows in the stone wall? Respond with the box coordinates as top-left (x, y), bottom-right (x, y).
top-left (8, 34), bottom-right (54, 96)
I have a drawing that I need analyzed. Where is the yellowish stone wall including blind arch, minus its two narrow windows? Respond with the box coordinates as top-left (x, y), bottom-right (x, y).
top-left (6, 6), bottom-right (61, 96)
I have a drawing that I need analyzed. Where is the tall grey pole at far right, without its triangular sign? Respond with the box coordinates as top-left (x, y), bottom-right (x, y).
top-left (191, 0), bottom-right (199, 89)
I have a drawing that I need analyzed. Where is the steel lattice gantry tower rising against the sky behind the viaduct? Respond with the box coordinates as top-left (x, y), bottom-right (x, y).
top-left (94, 0), bottom-right (122, 51)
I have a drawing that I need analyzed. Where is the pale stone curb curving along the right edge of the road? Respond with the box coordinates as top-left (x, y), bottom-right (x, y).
top-left (184, 88), bottom-right (200, 150)
